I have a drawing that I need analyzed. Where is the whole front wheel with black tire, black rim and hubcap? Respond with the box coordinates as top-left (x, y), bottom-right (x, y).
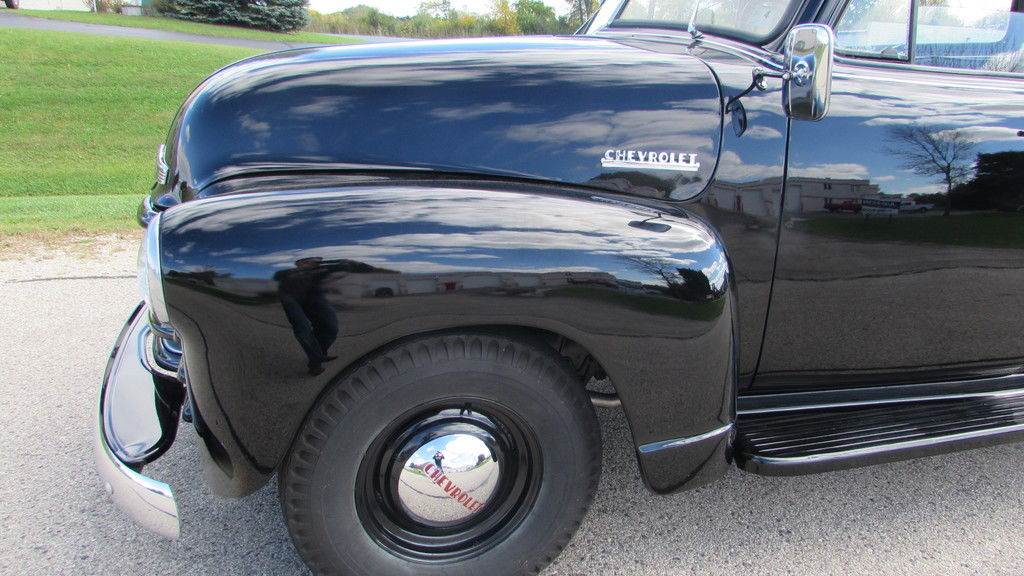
top-left (280, 333), bottom-right (601, 576)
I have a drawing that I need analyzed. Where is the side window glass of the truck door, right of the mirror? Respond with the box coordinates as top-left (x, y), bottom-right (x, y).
top-left (836, 0), bottom-right (1024, 73)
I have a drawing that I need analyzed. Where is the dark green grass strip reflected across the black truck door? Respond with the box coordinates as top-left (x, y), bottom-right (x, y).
top-left (797, 212), bottom-right (1024, 248)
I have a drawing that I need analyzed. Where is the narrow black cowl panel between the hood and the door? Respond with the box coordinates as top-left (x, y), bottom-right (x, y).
top-left (589, 32), bottom-right (790, 383)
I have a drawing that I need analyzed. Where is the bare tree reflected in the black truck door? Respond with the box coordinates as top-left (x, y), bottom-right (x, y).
top-left (887, 124), bottom-right (974, 216)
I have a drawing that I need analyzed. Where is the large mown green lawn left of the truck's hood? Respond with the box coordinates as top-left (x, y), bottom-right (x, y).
top-left (0, 29), bottom-right (257, 234)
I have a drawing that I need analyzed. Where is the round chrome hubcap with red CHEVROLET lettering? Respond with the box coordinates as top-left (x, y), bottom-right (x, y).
top-left (397, 423), bottom-right (501, 528)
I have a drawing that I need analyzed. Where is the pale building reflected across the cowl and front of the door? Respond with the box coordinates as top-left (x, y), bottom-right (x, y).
top-left (701, 177), bottom-right (880, 217)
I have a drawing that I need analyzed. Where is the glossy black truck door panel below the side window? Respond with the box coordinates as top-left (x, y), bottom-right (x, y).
top-left (755, 49), bottom-right (1024, 392)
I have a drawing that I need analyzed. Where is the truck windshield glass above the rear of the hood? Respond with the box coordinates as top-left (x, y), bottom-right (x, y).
top-left (610, 0), bottom-right (800, 43)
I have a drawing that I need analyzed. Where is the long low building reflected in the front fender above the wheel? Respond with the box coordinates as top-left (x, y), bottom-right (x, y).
top-left (330, 272), bottom-right (618, 298)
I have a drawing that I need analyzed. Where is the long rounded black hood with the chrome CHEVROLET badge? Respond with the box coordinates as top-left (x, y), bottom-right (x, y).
top-left (157, 37), bottom-right (722, 199)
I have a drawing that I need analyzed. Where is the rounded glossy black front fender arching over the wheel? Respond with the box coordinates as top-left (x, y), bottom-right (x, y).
top-left (161, 181), bottom-right (735, 494)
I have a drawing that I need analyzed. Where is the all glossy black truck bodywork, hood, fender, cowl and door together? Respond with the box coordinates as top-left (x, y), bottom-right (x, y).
top-left (152, 3), bottom-right (1024, 494)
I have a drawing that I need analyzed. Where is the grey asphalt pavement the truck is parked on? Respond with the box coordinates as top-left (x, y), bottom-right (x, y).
top-left (0, 238), bottom-right (1024, 576)
